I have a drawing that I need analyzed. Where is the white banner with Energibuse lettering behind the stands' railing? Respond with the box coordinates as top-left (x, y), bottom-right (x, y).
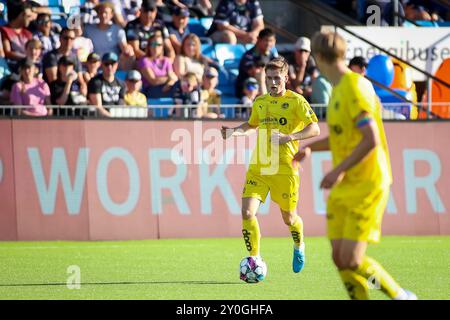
top-left (323, 26), bottom-right (450, 81)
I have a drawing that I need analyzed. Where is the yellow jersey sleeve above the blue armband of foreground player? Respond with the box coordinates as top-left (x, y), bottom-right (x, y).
top-left (347, 77), bottom-right (376, 119)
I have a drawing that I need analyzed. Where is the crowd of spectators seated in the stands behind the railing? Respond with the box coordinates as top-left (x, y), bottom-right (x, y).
top-left (0, 0), bottom-right (448, 118)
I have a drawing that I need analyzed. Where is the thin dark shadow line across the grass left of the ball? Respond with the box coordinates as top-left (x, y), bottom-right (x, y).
top-left (0, 280), bottom-right (243, 287)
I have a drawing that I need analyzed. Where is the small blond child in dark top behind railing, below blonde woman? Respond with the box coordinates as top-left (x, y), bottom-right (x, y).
top-left (171, 72), bottom-right (202, 118)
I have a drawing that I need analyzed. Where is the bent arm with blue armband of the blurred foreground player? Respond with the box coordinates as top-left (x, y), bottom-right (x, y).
top-left (320, 111), bottom-right (380, 189)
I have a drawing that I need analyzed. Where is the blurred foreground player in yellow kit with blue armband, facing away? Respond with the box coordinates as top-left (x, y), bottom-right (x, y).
top-left (294, 32), bottom-right (417, 300)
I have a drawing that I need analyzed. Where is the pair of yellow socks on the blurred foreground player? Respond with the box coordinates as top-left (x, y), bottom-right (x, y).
top-left (339, 256), bottom-right (403, 300)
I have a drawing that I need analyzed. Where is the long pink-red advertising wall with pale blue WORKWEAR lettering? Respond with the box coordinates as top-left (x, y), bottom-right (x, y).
top-left (0, 119), bottom-right (450, 240)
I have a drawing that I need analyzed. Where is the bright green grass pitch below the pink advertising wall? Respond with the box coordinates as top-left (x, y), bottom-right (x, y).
top-left (0, 236), bottom-right (450, 300)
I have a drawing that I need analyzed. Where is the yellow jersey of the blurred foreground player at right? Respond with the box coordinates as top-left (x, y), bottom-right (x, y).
top-left (327, 72), bottom-right (392, 194)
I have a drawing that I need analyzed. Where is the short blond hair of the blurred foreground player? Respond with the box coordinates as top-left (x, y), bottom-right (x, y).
top-left (311, 32), bottom-right (347, 64)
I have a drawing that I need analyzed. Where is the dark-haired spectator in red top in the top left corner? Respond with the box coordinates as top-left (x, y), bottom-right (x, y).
top-left (0, 1), bottom-right (33, 69)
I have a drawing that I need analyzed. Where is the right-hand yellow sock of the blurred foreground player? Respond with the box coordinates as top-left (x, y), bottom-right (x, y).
top-left (355, 256), bottom-right (402, 299)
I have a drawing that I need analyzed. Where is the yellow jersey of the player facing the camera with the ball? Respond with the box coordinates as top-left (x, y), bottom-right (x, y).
top-left (248, 90), bottom-right (317, 175)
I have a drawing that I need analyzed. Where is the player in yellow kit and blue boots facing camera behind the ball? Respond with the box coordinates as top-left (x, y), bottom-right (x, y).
top-left (222, 58), bottom-right (320, 273)
